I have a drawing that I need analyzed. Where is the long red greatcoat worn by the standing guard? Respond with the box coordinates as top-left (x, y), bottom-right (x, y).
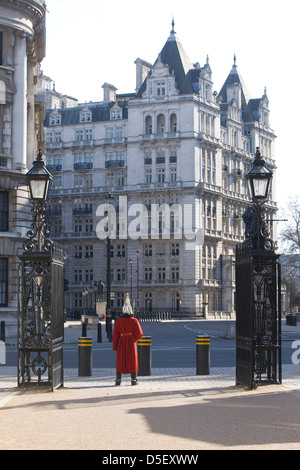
top-left (112, 314), bottom-right (143, 374)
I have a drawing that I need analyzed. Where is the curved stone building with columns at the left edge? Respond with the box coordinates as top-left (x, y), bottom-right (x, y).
top-left (0, 0), bottom-right (45, 336)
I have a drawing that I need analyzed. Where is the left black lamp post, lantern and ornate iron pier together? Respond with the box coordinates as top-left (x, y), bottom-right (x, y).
top-left (18, 150), bottom-right (64, 391)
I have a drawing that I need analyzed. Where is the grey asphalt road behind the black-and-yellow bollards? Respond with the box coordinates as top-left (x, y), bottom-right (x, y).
top-left (6, 320), bottom-right (300, 369)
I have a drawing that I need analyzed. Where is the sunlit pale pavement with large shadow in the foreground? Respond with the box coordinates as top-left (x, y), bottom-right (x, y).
top-left (0, 326), bottom-right (300, 450)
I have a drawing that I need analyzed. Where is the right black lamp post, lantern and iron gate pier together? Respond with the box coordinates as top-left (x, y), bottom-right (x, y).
top-left (236, 148), bottom-right (282, 388)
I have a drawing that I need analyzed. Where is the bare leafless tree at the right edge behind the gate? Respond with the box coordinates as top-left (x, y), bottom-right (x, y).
top-left (280, 197), bottom-right (300, 253)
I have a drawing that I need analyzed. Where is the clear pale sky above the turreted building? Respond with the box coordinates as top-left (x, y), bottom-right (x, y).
top-left (42, 0), bottom-right (300, 217)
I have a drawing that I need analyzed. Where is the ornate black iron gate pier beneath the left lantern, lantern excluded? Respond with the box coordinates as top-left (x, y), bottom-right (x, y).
top-left (18, 243), bottom-right (64, 391)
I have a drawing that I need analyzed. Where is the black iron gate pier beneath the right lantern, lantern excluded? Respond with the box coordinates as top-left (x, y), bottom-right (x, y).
top-left (236, 252), bottom-right (282, 388)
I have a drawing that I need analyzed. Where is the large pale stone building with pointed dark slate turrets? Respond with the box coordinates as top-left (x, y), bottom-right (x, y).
top-left (45, 24), bottom-right (276, 316)
